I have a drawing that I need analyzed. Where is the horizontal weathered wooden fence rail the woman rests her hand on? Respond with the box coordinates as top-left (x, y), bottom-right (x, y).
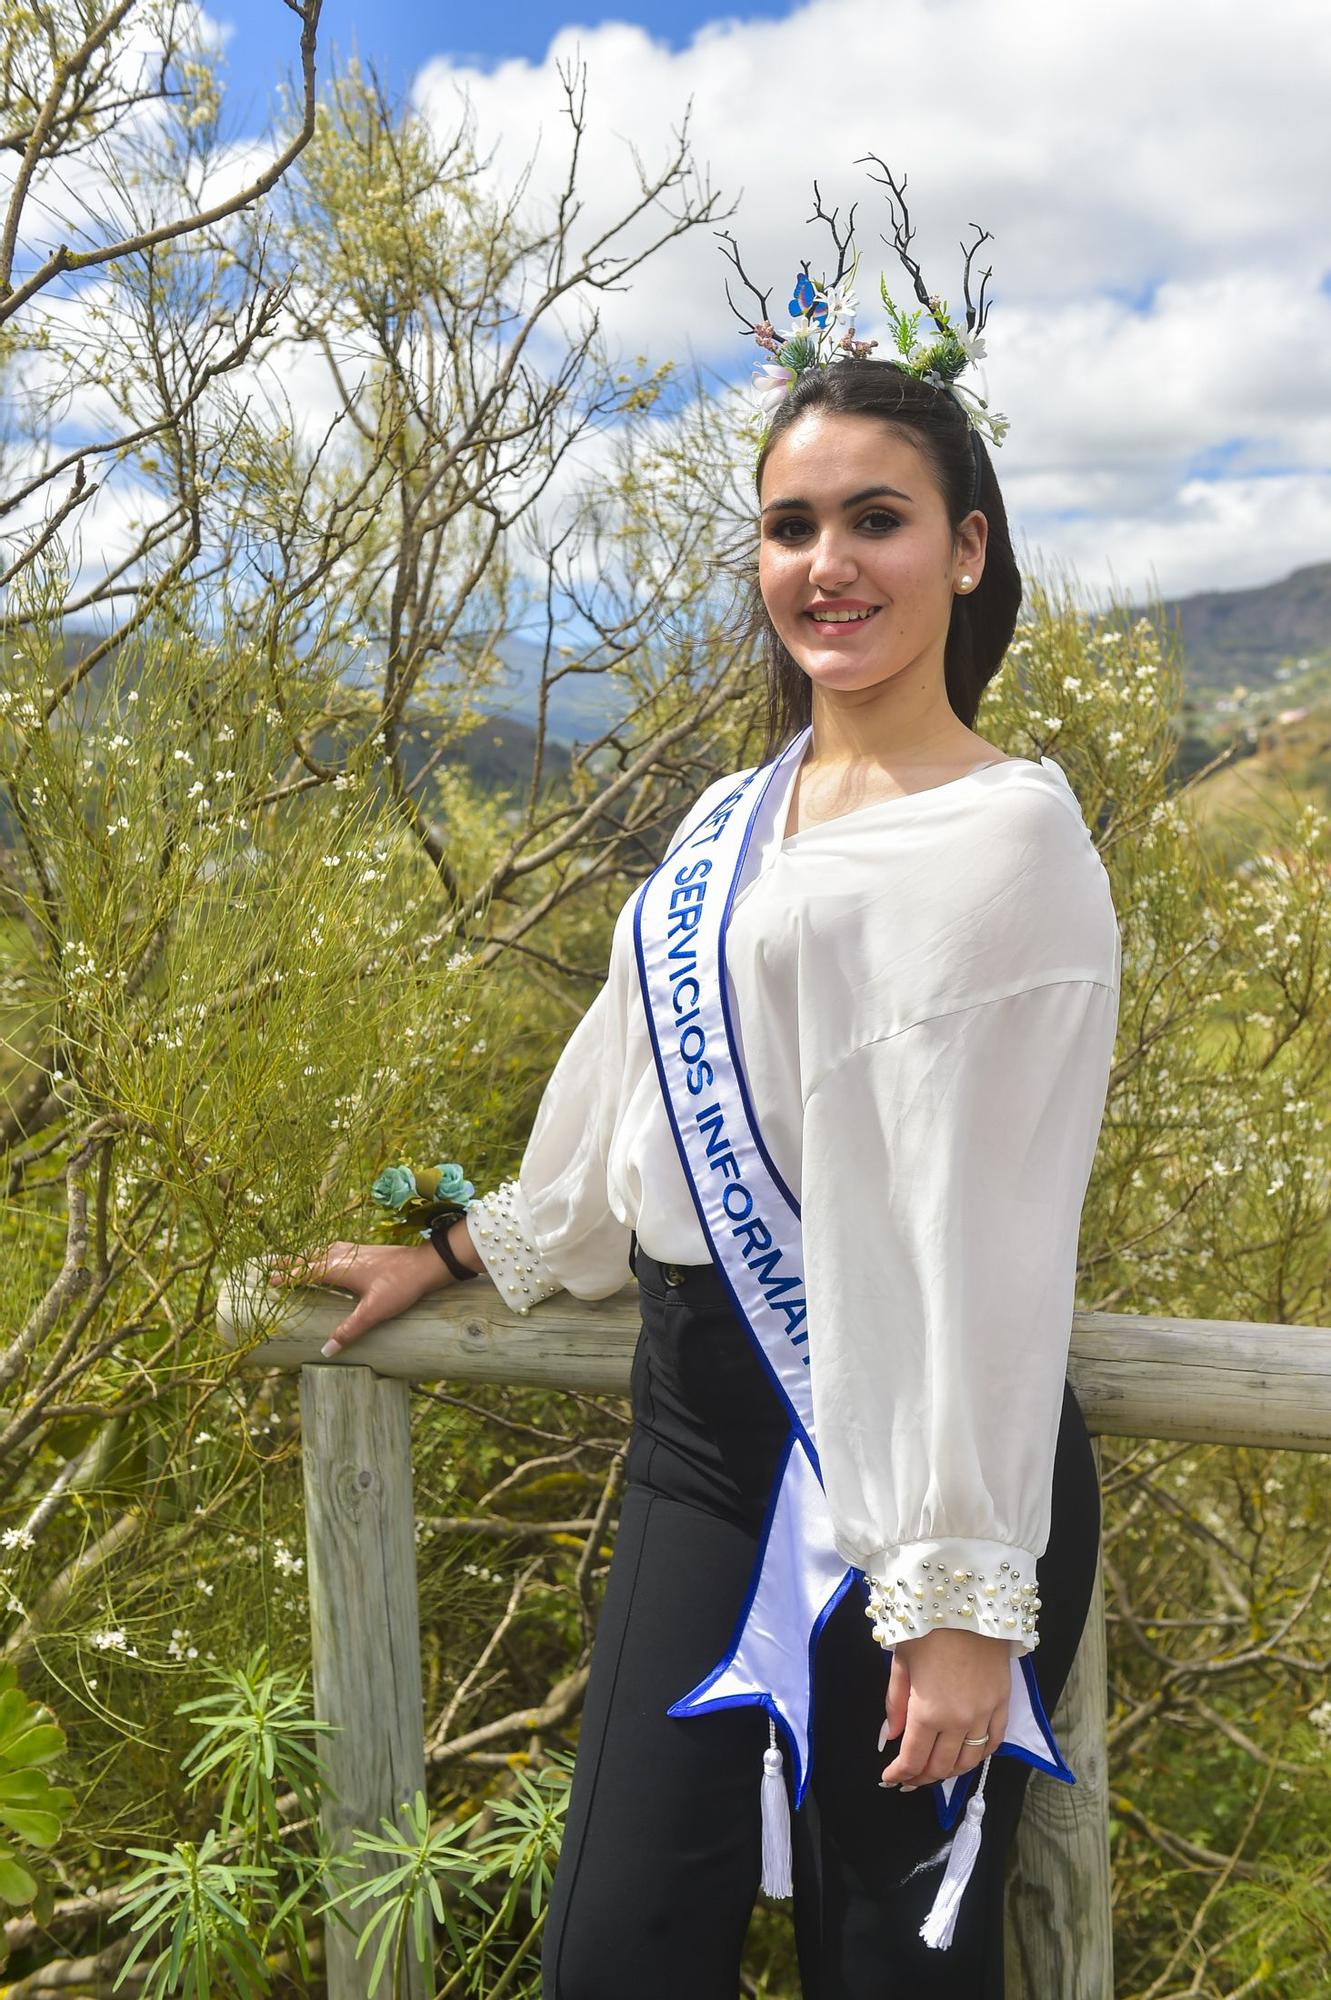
top-left (218, 1272), bottom-right (1331, 1452)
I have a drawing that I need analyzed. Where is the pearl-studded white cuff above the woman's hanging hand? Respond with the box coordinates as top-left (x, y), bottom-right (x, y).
top-left (865, 1542), bottom-right (1039, 1654)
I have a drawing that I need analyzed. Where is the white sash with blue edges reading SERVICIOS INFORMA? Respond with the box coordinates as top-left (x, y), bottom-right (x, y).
top-left (634, 728), bottom-right (1075, 1920)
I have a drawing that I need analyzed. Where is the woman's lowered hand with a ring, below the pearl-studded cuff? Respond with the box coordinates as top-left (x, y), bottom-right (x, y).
top-left (877, 1626), bottom-right (1011, 1792)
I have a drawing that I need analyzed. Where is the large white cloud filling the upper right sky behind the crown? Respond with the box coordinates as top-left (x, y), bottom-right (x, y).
top-left (414, 0), bottom-right (1331, 596)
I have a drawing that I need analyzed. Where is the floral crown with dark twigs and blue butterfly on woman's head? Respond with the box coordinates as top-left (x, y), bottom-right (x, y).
top-left (715, 152), bottom-right (1009, 464)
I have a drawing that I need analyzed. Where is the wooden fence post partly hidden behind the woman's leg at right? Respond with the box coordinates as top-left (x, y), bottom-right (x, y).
top-left (1007, 1438), bottom-right (1113, 2000)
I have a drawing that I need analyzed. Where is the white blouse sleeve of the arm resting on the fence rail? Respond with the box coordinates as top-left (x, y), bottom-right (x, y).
top-left (468, 776), bottom-right (733, 1312)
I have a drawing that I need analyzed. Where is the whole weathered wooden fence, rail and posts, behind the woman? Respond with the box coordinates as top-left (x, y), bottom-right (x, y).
top-left (218, 1266), bottom-right (1331, 2000)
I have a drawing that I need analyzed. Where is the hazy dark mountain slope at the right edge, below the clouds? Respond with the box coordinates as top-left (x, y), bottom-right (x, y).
top-left (1133, 562), bottom-right (1331, 694)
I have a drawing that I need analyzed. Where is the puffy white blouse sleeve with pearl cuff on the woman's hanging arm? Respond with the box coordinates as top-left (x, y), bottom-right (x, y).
top-left (801, 978), bottom-right (1119, 1654)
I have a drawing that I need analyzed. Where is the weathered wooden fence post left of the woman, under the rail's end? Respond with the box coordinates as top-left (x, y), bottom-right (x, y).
top-left (300, 1362), bottom-right (434, 2000)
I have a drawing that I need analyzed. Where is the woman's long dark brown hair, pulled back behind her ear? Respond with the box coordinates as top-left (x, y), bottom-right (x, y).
top-left (749, 358), bottom-right (1021, 764)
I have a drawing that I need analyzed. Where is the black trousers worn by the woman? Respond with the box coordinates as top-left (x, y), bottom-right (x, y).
top-left (542, 1248), bottom-right (1099, 2000)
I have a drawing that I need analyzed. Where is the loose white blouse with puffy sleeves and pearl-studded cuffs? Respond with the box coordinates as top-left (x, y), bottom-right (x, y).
top-left (468, 752), bottom-right (1121, 1654)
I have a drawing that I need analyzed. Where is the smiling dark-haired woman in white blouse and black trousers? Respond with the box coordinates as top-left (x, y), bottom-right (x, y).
top-left (273, 356), bottom-right (1119, 2000)
